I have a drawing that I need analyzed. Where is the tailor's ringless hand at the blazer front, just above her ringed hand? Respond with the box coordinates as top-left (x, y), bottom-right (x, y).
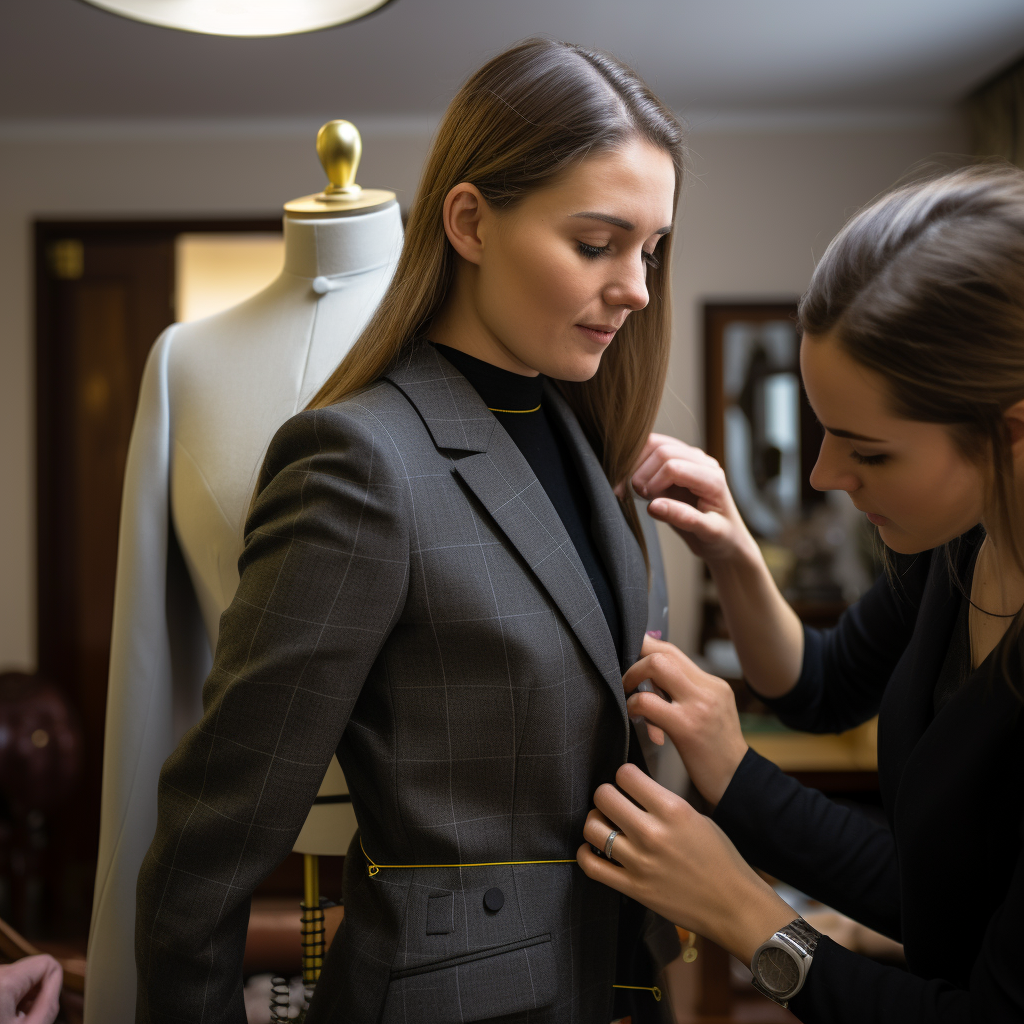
top-left (623, 636), bottom-right (746, 806)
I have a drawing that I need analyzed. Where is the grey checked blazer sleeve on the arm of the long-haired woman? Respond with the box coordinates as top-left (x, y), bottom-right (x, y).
top-left (135, 403), bottom-right (410, 1024)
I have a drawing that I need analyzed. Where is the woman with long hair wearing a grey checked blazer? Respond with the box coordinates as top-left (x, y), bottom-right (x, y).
top-left (136, 41), bottom-right (682, 1024)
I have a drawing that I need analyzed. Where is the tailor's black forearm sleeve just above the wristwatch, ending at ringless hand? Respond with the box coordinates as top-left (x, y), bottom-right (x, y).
top-left (714, 751), bottom-right (900, 937)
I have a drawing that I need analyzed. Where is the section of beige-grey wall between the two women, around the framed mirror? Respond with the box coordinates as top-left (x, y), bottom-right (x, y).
top-left (658, 113), bottom-right (968, 644)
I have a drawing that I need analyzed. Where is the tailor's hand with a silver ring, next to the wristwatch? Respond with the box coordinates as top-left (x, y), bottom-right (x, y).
top-left (577, 765), bottom-right (797, 964)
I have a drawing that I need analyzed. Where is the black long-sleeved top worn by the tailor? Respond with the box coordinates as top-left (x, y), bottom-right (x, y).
top-left (714, 528), bottom-right (1024, 1024)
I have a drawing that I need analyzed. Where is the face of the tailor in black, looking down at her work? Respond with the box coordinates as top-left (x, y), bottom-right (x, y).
top-left (800, 335), bottom-right (986, 554)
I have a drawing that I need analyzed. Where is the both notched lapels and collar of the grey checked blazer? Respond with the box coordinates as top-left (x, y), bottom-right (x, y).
top-left (386, 342), bottom-right (647, 737)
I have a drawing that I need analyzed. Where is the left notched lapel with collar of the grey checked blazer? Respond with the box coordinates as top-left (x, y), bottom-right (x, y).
top-left (386, 343), bottom-right (622, 722)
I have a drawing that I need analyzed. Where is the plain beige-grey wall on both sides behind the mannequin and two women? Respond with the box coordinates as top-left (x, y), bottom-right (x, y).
top-left (0, 115), bottom-right (966, 671)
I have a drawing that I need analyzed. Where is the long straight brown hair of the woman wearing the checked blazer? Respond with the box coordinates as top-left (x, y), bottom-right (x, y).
top-left (309, 39), bottom-right (683, 557)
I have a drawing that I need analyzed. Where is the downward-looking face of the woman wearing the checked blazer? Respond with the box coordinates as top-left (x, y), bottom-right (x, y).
top-left (444, 141), bottom-right (676, 381)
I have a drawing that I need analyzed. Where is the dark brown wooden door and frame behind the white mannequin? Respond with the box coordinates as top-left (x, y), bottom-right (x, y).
top-left (34, 219), bottom-right (281, 934)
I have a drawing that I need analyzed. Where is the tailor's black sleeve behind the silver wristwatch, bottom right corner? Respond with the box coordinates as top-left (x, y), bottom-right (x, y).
top-left (790, 839), bottom-right (1024, 1024)
